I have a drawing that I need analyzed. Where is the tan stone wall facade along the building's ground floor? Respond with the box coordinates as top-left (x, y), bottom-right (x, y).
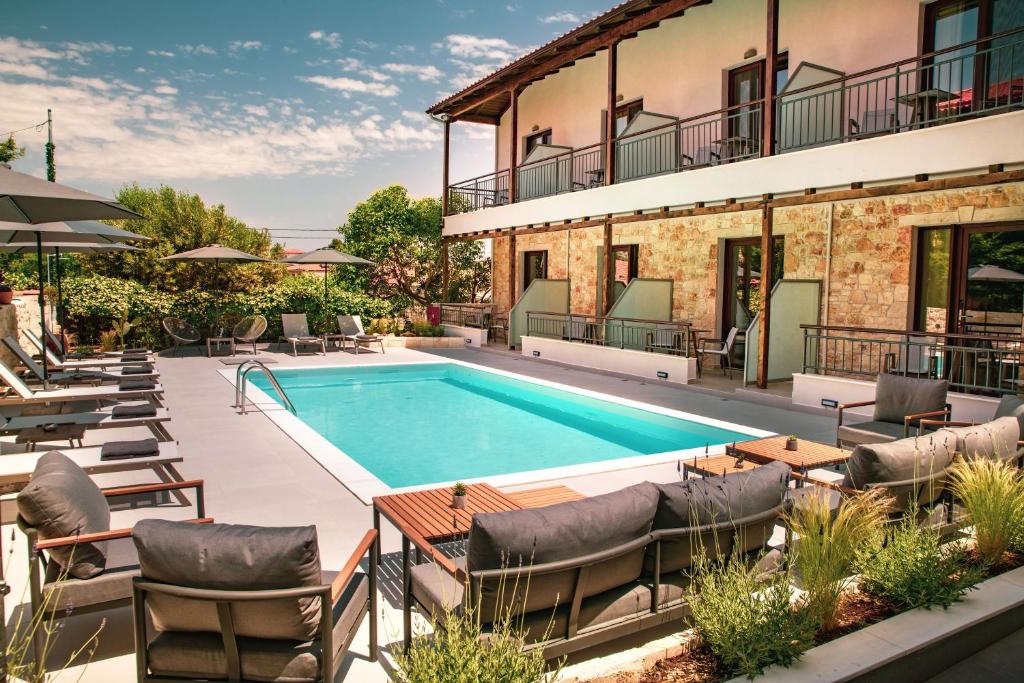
top-left (493, 182), bottom-right (1024, 330)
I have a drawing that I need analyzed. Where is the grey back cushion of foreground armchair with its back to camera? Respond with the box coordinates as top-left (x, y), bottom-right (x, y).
top-left (132, 519), bottom-right (323, 640)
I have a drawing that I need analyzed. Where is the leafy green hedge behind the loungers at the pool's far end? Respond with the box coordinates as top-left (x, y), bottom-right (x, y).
top-left (63, 275), bottom-right (400, 348)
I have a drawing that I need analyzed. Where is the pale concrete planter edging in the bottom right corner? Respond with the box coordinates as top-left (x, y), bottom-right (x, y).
top-left (729, 567), bottom-right (1024, 683)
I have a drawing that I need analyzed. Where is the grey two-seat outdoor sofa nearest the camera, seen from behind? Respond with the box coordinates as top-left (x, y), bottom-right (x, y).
top-left (403, 463), bottom-right (791, 658)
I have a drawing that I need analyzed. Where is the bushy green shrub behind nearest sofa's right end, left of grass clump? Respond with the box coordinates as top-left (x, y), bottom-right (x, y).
top-left (690, 556), bottom-right (815, 679)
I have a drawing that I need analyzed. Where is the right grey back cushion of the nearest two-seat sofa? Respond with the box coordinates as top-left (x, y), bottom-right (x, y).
top-left (644, 462), bottom-right (791, 573)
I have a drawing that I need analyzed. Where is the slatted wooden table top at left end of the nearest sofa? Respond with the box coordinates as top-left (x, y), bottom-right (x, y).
top-left (374, 483), bottom-right (522, 543)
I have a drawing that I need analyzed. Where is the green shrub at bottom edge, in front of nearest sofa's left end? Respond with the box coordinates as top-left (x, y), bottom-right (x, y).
top-left (395, 610), bottom-right (558, 683)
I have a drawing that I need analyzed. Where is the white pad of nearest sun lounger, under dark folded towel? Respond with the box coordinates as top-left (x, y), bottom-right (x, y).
top-left (0, 442), bottom-right (184, 494)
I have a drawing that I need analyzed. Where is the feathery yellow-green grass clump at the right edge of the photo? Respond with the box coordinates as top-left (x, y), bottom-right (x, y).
top-left (952, 458), bottom-right (1024, 564)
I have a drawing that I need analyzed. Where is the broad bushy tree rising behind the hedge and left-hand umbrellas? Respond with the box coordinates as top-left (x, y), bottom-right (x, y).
top-left (82, 183), bottom-right (285, 292)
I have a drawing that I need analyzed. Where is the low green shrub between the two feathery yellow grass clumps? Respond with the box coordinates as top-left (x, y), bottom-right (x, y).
top-left (857, 510), bottom-right (984, 609)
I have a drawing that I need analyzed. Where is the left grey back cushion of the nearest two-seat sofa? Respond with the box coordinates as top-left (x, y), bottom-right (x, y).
top-left (468, 482), bottom-right (658, 621)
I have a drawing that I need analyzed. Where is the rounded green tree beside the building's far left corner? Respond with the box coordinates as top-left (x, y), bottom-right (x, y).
top-left (332, 185), bottom-right (490, 305)
